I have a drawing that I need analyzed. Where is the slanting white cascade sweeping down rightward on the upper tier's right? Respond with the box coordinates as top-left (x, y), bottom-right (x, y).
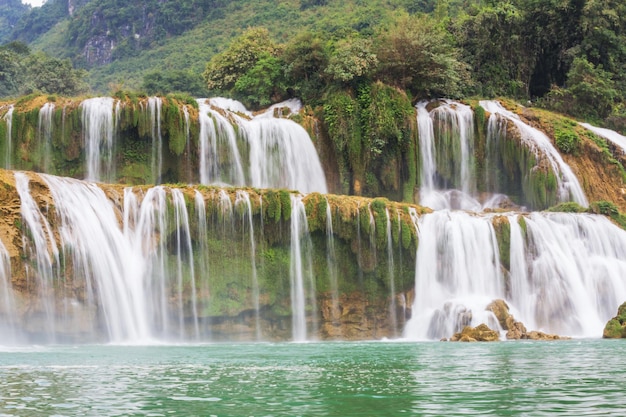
top-left (480, 100), bottom-right (588, 207)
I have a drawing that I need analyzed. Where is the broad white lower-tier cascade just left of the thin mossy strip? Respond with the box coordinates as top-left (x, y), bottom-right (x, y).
top-left (405, 210), bottom-right (503, 339)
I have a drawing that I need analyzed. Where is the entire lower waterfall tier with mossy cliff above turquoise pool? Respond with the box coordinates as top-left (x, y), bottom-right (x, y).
top-left (0, 171), bottom-right (626, 344)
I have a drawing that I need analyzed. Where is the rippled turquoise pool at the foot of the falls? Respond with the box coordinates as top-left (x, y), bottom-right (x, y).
top-left (0, 340), bottom-right (626, 416)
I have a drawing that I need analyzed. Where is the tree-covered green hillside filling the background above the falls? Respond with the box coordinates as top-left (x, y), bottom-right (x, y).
top-left (0, 0), bottom-right (626, 130)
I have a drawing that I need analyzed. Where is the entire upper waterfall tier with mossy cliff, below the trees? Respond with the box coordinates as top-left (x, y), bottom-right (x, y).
top-left (0, 95), bottom-right (626, 212)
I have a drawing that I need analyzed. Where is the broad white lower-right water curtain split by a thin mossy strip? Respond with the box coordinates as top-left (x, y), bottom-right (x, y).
top-left (405, 211), bottom-right (626, 340)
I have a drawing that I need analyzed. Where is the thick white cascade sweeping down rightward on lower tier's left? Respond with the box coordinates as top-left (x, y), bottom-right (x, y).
top-left (41, 174), bottom-right (149, 342)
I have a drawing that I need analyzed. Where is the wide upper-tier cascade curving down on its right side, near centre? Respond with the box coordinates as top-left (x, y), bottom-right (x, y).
top-left (198, 99), bottom-right (327, 193)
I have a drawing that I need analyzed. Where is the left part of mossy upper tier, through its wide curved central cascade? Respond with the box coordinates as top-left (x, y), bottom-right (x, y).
top-left (0, 97), bottom-right (327, 193)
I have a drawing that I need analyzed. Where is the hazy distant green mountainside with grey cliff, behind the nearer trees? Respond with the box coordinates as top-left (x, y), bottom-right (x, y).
top-left (11, 0), bottom-right (432, 92)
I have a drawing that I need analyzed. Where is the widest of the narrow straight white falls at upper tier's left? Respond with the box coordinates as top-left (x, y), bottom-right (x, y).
top-left (80, 97), bottom-right (115, 181)
